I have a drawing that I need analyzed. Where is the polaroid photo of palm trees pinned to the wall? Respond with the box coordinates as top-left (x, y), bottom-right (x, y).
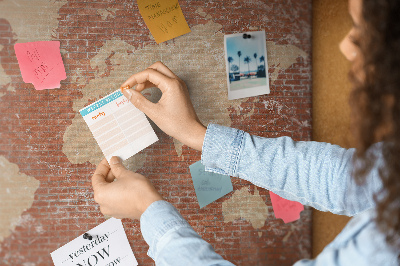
top-left (224, 31), bottom-right (270, 100)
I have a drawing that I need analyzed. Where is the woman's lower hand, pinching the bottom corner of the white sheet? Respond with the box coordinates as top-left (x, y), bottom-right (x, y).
top-left (92, 156), bottom-right (163, 219)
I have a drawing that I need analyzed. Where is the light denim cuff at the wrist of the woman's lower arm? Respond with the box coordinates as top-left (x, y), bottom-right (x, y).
top-left (140, 200), bottom-right (190, 260)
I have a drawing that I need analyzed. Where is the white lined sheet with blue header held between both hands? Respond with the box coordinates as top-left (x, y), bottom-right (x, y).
top-left (79, 90), bottom-right (158, 161)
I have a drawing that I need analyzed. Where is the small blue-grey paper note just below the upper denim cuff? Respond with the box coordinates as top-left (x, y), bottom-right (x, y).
top-left (189, 161), bottom-right (233, 208)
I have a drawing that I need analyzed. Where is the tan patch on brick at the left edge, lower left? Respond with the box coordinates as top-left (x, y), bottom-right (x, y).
top-left (0, 156), bottom-right (39, 242)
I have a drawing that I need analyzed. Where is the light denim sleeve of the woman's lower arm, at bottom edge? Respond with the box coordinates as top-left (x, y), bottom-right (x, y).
top-left (140, 201), bottom-right (233, 265)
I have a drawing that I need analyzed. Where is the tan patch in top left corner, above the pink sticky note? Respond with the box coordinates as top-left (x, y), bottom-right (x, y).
top-left (0, 0), bottom-right (67, 42)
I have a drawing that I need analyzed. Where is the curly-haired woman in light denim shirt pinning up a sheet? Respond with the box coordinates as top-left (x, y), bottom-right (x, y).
top-left (92, 0), bottom-right (400, 265)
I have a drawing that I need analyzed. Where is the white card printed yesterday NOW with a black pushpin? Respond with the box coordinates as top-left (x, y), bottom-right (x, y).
top-left (51, 218), bottom-right (138, 266)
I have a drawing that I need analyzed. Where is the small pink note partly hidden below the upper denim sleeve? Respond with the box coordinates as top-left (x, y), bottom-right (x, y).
top-left (269, 191), bottom-right (304, 224)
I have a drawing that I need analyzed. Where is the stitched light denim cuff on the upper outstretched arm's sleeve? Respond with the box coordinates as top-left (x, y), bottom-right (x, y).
top-left (201, 124), bottom-right (244, 176)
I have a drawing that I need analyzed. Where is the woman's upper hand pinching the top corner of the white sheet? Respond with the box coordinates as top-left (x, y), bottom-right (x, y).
top-left (121, 62), bottom-right (206, 151)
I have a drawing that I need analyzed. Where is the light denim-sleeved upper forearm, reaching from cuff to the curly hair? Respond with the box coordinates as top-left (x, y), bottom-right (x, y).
top-left (202, 125), bottom-right (380, 215)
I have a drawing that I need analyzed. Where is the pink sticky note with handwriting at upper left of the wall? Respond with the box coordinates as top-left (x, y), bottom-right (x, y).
top-left (14, 41), bottom-right (67, 90)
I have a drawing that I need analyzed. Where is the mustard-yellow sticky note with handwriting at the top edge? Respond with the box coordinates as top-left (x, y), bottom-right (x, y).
top-left (137, 0), bottom-right (190, 43)
